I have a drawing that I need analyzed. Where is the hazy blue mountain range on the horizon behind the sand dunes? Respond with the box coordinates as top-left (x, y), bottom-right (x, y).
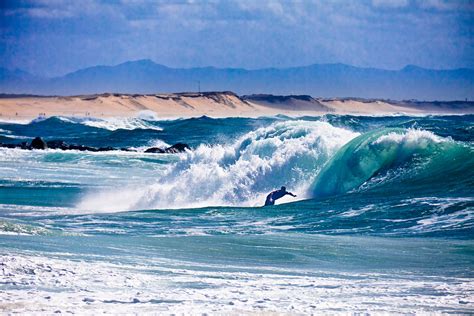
top-left (0, 60), bottom-right (474, 100)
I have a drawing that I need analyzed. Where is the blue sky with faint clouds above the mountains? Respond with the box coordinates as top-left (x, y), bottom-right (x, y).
top-left (0, 0), bottom-right (474, 76)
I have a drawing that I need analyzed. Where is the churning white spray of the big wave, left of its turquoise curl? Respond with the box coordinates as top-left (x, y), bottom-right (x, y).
top-left (79, 121), bottom-right (358, 211)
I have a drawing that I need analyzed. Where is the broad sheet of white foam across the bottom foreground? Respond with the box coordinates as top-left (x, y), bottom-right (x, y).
top-left (0, 253), bottom-right (474, 315)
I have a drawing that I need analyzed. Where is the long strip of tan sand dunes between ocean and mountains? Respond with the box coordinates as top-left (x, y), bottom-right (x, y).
top-left (0, 92), bottom-right (474, 119)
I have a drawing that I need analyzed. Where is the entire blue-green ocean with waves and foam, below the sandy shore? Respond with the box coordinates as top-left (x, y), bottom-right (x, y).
top-left (0, 113), bottom-right (474, 314)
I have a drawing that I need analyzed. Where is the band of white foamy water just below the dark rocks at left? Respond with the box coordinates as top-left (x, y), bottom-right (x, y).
top-left (0, 148), bottom-right (172, 202)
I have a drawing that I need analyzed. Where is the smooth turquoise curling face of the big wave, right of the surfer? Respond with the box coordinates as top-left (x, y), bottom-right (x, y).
top-left (313, 129), bottom-right (474, 197)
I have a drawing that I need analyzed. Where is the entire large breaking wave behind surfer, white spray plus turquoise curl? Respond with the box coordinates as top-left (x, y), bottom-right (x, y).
top-left (79, 121), bottom-right (474, 215)
